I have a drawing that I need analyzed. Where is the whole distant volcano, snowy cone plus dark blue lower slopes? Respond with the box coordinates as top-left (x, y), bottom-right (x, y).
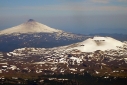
top-left (0, 19), bottom-right (88, 52)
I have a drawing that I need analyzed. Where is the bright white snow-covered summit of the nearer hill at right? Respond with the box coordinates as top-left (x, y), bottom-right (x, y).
top-left (69, 37), bottom-right (123, 52)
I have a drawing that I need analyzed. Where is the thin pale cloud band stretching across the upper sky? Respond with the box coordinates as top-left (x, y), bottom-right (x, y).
top-left (3, 3), bottom-right (127, 16)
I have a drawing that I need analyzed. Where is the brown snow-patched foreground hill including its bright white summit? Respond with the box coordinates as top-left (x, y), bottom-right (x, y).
top-left (0, 37), bottom-right (127, 85)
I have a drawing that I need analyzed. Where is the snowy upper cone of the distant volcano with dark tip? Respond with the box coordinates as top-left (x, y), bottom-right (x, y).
top-left (0, 19), bottom-right (62, 34)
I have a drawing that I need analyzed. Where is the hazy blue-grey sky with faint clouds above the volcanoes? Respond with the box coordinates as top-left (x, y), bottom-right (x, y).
top-left (0, 0), bottom-right (127, 34)
